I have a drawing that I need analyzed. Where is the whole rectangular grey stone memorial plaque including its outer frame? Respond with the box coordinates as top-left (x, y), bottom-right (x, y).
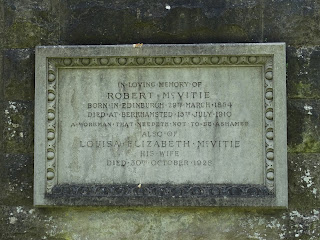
top-left (34, 43), bottom-right (288, 207)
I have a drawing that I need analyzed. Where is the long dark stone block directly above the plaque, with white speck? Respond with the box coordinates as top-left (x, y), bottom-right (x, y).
top-left (60, 0), bottom-right (262, 45)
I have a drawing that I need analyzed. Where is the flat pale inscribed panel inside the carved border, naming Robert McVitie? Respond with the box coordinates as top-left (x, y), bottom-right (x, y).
top-left (58, 67), bottom-right (264, 184)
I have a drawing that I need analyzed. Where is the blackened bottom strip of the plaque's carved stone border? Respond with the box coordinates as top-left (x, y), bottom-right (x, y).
top-left (48, 184), bottom-right (272, 198)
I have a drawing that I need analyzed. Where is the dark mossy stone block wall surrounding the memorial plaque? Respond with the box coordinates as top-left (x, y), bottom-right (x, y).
top-left (0, 0), bottom-right (320, 240)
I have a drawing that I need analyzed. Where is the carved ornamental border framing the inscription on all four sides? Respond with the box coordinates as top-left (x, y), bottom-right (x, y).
top-left (46, 55), bottom-right (275, 197)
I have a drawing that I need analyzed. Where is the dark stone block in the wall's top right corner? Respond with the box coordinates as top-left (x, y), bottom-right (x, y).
top-left (263, 0), bottom-right (320, 46)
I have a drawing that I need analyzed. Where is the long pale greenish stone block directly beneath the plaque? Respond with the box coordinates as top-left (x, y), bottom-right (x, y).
top-left (49, 208), bottom-right (288, 240)
